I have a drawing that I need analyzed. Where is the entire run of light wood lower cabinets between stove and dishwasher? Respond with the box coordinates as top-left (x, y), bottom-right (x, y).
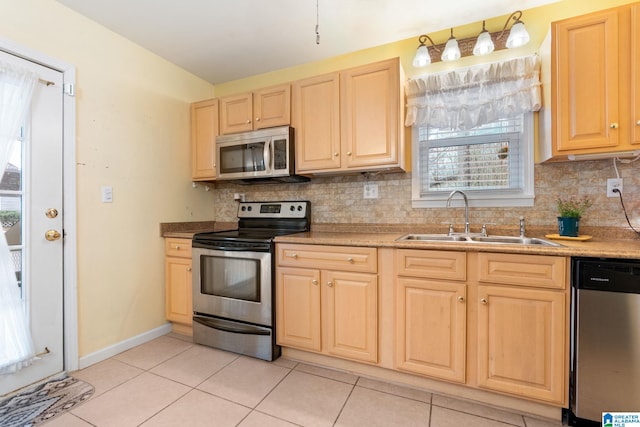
top-left (276, 243), bottom-right (570, 407)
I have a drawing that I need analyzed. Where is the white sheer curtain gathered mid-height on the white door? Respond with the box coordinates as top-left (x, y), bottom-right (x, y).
top-left (0, 61), bottom-right (38, 374)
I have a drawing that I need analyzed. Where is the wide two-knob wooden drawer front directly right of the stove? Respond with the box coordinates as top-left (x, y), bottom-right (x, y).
top-left (276, 244), bottom-right (378, 273)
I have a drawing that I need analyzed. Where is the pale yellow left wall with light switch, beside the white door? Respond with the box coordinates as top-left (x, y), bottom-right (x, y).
top-left (0, 0), bottom-right (213, 356)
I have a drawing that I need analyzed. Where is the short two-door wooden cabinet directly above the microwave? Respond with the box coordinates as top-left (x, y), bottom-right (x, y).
top-left (220, 84), bottom-right (291, 135)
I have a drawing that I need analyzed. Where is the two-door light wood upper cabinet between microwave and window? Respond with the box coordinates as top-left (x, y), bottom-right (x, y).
top-left (293, 58), bottom-right (405, 174)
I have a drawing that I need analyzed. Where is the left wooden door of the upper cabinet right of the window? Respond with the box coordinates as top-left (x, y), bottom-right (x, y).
top-left (552, 10), bottom-right (622, 155)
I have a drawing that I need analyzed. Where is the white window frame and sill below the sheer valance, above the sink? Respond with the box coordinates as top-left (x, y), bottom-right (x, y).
top-left (411, 112), bottom-right (535, 208)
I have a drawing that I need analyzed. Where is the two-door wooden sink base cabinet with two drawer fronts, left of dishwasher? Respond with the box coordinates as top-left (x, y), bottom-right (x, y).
top-left (395, 249), bottom-right (569, 406)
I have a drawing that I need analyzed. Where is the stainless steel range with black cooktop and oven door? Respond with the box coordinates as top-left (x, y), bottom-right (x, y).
top-left (192, 201), bottom-right (311, 360)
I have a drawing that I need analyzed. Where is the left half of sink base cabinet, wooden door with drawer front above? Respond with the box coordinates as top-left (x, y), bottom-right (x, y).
top-left (396, 250), bottom-right (467, 383)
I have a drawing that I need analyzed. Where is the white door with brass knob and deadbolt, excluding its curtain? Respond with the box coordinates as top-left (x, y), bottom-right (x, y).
top-left (0, 52), bottom-right (64, 396)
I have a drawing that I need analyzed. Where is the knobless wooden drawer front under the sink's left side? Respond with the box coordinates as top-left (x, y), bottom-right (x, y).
top-left (396, 249), bottom-right (467, 280)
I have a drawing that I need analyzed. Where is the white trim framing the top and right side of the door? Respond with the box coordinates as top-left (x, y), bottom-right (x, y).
top-left (0, 37), bottom-right (79, 372)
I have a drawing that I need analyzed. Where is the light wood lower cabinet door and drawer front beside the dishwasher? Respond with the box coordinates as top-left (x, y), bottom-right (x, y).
top-left (476, 253), bottom-right (569, 405)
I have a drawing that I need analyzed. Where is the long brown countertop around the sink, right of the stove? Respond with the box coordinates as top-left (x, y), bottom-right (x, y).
top-left (276, 231), bottom-right (640, 259)
